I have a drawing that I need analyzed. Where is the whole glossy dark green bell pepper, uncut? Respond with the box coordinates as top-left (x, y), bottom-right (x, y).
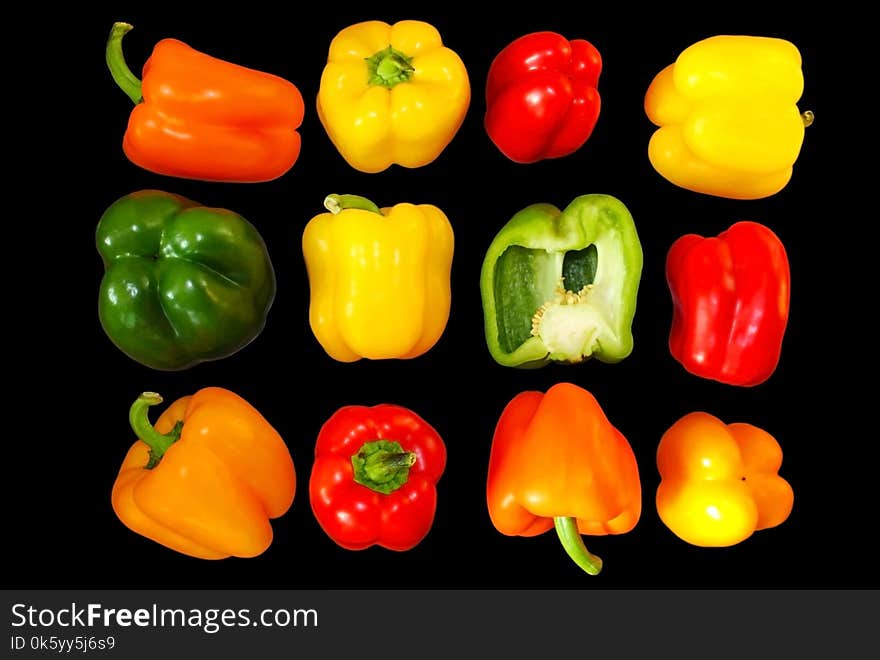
top-left (96, 190), bottom-right (275, 370)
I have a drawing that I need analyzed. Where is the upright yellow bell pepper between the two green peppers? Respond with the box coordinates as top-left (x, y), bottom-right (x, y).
top-left (302, 195), bottom-right (454, 362)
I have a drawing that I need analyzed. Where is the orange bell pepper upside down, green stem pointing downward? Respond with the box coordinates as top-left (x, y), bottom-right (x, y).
top-left (486, 383), bottom-right (642, 575)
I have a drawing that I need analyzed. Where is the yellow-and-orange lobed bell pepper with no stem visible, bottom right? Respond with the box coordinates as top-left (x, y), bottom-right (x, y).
top-left (656, 412), bottom-right (794, 547)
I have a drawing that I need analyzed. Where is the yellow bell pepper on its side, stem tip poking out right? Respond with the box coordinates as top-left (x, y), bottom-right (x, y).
top-left (645, 35), bottom-right (813, 199)
